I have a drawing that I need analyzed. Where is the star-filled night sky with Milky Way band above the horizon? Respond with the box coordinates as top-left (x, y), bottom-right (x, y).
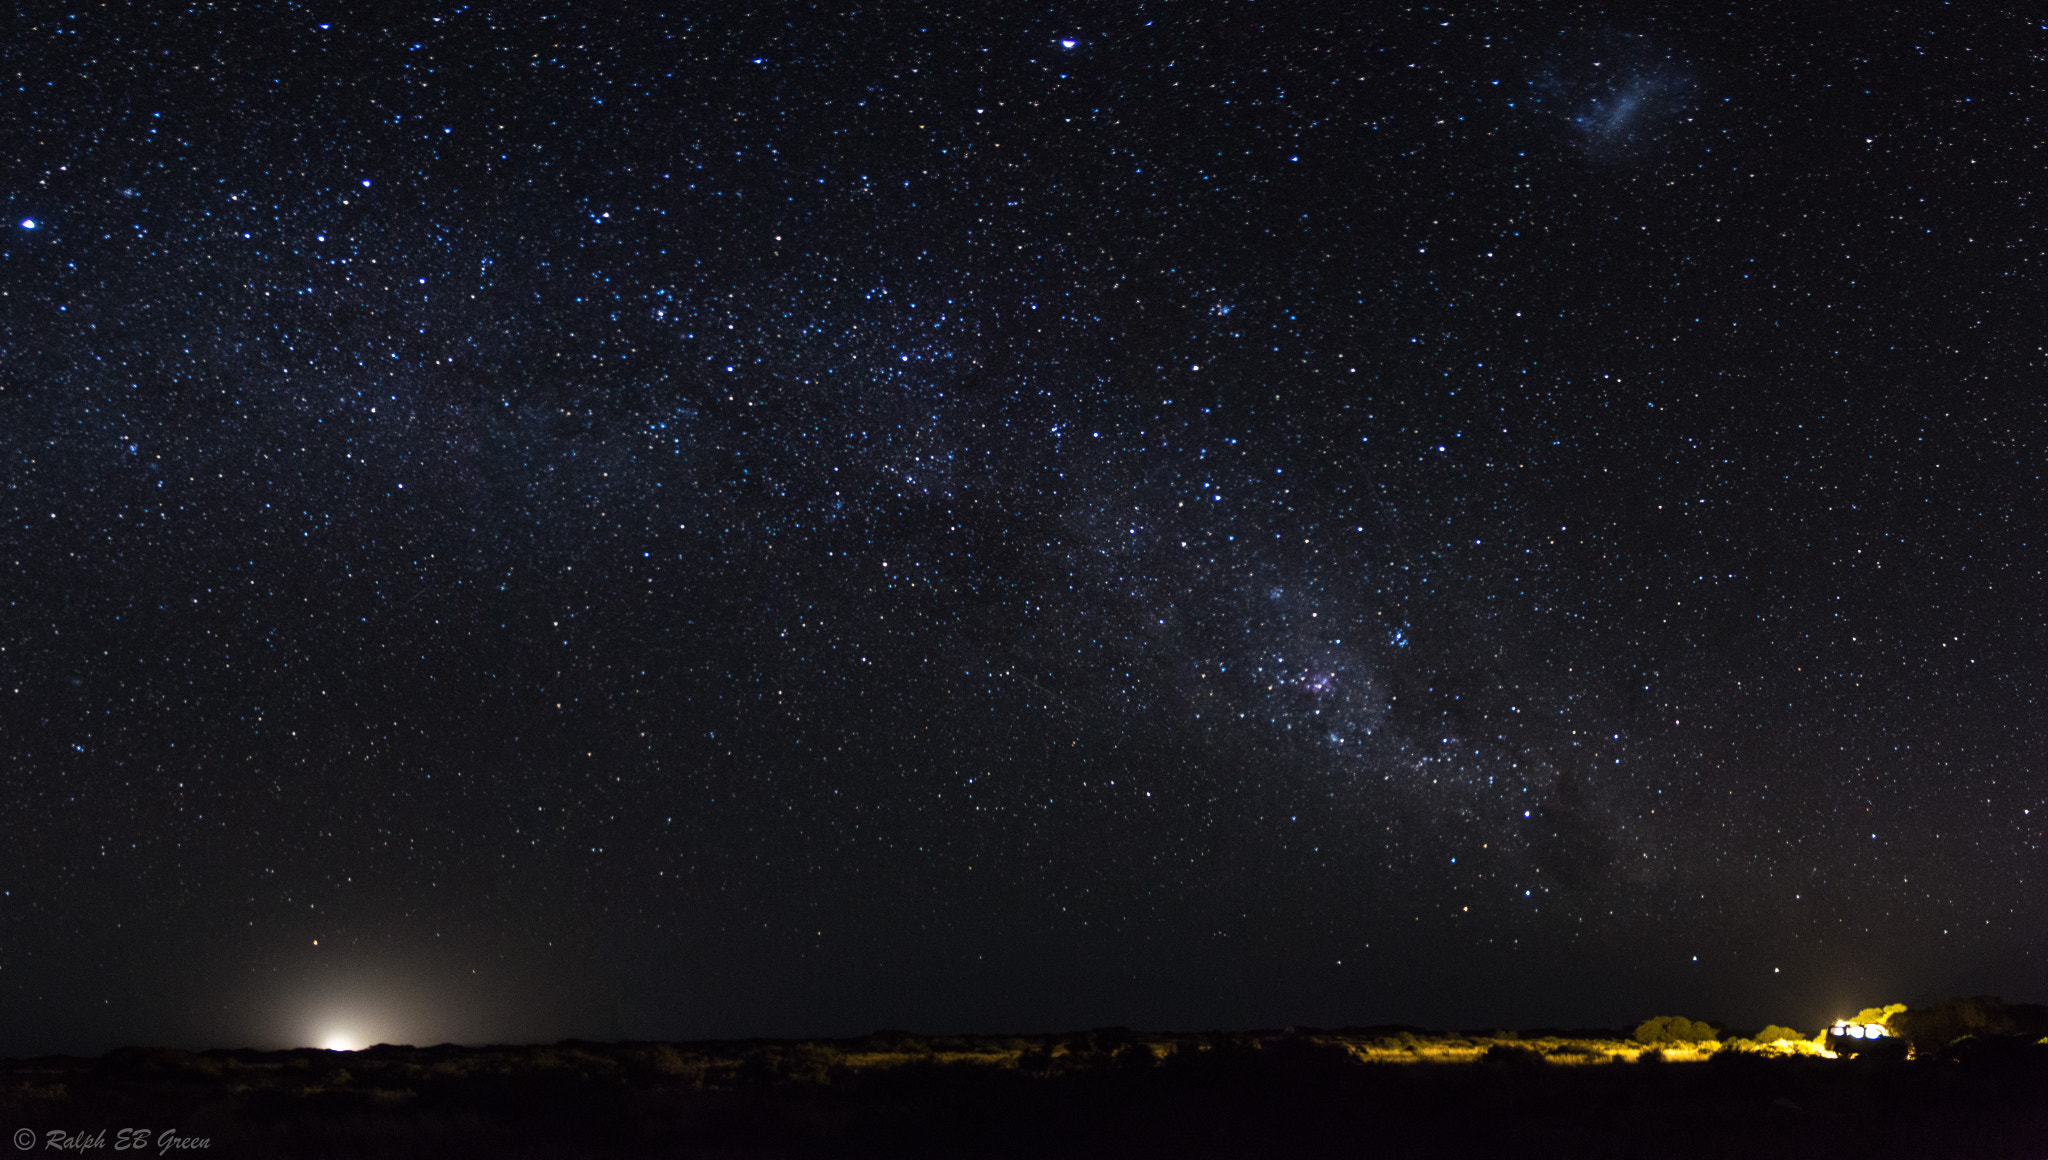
top-left (0, 2), bottom-right (2048, 1053)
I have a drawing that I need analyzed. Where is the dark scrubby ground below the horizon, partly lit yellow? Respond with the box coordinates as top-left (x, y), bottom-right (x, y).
top-left (0, 1033), bottom-right (2048, 1160)
